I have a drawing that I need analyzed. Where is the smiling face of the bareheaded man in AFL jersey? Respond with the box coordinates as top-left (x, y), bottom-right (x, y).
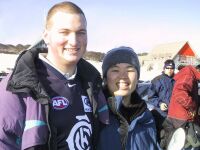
top-left (44, 12), bottom-right (87, 67)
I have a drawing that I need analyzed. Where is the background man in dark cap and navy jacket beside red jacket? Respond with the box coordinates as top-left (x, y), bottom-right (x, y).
top-left (148, 59), bottom-right (175, 142)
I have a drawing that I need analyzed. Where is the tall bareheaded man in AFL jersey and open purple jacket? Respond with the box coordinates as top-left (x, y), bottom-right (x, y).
top-left (0, 2), bottom-right (108, 150)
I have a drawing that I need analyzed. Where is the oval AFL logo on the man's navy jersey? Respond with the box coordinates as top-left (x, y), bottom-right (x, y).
top-left (52, 96), bottom-right (69, 110)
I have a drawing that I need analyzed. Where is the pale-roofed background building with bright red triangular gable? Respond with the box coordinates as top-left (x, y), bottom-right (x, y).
top-left (143, 41), bottom-right (199, 70)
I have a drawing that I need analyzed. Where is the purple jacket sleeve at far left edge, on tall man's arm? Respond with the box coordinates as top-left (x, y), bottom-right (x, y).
top-left (0, 80), bottom-right (25, 150)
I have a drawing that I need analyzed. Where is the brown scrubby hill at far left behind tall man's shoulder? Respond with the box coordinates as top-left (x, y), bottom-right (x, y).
top-left (0, 43), bottom-right (30, 54)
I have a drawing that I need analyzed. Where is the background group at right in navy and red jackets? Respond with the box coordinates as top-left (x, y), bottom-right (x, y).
top-left (147, 60), bottom-right (200, 149)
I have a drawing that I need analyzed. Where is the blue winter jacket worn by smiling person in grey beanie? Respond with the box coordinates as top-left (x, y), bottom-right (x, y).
top-left (97, 91), bottom-right (160, 150)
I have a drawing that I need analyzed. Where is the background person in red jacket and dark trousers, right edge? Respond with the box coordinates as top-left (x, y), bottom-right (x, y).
top-left (161, 65), bottom-right (200, 149)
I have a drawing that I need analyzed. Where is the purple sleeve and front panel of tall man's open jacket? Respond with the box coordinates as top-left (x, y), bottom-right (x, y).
top-left (0, 77), bottom-right (48, 150)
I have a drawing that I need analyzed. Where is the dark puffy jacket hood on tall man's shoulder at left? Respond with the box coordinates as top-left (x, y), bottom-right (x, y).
top-left (7, 48), bottom-right (48, 103)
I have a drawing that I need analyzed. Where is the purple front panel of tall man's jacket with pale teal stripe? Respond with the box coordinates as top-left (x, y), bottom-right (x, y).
top-left (21, 97), bottom-right (48, 149)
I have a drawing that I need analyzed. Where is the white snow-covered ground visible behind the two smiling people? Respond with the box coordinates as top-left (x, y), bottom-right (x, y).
top-left (0, 54), bottom-right (162, 81)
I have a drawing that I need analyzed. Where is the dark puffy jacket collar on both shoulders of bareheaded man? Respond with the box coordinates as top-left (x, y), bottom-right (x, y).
top-left (7, 48), bottom-right (101, 104)
